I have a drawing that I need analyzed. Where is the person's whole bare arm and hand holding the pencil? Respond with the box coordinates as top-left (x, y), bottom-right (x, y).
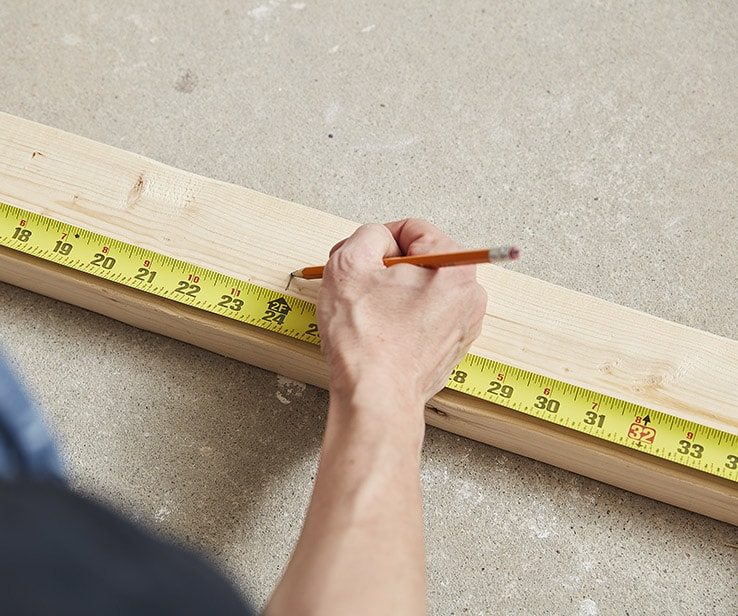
top-left (266, 220), bottom-right (486, 616)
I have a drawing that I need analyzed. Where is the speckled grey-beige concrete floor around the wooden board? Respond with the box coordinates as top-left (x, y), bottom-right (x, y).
top-left (0, 0), bottom-right (738, 615)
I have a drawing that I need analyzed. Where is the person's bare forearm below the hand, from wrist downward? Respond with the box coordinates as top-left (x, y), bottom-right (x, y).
top-left (267, 383), bottom-right (425, 615)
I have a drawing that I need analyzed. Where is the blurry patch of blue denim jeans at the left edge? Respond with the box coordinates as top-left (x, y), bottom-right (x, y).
top-left (0, 348), bottom-right (64, 481)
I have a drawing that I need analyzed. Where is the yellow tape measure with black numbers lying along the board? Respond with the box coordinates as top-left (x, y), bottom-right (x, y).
top-left (0, 202), bottom-right (738, 482)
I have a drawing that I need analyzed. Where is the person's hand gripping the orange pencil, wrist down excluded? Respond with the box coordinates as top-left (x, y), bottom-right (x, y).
top-left (317, 219), bottom-right (487, 404)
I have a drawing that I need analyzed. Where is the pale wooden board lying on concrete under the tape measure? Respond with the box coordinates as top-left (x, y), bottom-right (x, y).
top-left (0, 114), bottom-right (738, 524)
